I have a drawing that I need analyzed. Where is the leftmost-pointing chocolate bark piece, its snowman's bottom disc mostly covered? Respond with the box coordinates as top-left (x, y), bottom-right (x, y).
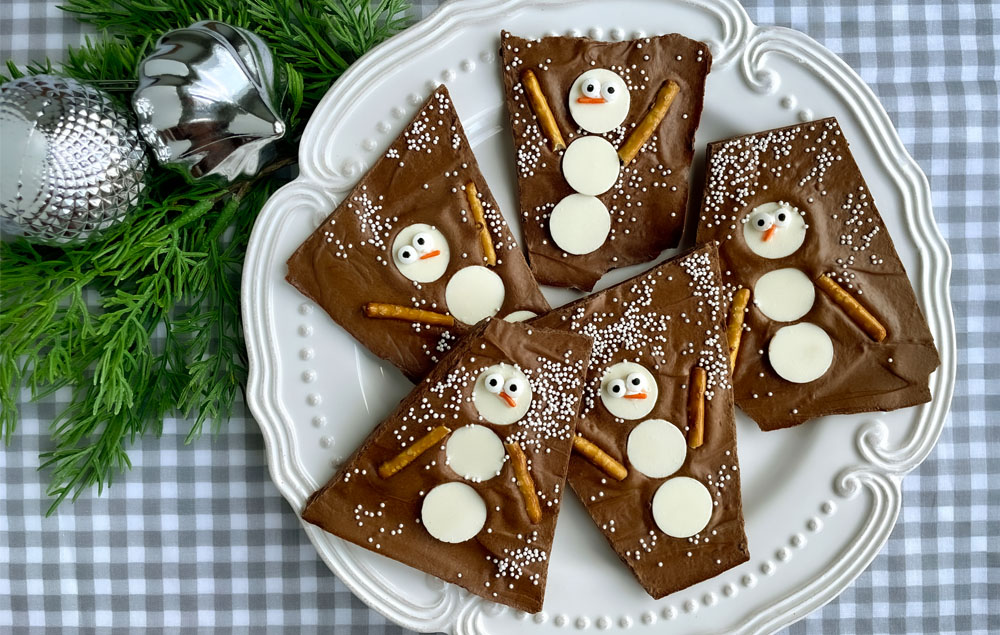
top-left (287, 86), bottom-right (549, 381)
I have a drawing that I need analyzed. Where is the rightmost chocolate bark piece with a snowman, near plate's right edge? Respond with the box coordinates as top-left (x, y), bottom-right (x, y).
top-left (697, 117), bottom-right (940, 430)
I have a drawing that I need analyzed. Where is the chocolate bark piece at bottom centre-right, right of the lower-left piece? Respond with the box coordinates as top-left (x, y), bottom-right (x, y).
top-left (531, 245), bottom-right (749, 598)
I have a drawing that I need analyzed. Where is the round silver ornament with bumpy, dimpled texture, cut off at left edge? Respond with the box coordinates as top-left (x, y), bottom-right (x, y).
top-left (0, 75), bottom-right (149, 245)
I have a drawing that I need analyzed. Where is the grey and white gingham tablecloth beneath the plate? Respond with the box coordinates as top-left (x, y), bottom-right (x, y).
top-left (0, 0), bottom-right (1000, 635)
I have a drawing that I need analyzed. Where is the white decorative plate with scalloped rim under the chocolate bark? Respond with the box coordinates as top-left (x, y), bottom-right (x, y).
top-left (243, 0), bottom-right (955, 635)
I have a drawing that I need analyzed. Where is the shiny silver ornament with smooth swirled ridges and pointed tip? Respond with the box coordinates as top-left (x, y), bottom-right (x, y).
top-left (132, 21), bottom-right (286, 183)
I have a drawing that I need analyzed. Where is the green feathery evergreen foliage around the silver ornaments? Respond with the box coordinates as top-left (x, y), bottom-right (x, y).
top-left (0, 0), bottom-right (409, 514)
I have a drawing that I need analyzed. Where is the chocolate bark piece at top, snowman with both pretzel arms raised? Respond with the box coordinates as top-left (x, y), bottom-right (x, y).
top-left (500, 31), bottom-right (712, 290)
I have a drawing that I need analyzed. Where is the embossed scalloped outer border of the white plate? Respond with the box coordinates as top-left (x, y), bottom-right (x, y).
top-left (243, 0), bottom-right (956, 634)
